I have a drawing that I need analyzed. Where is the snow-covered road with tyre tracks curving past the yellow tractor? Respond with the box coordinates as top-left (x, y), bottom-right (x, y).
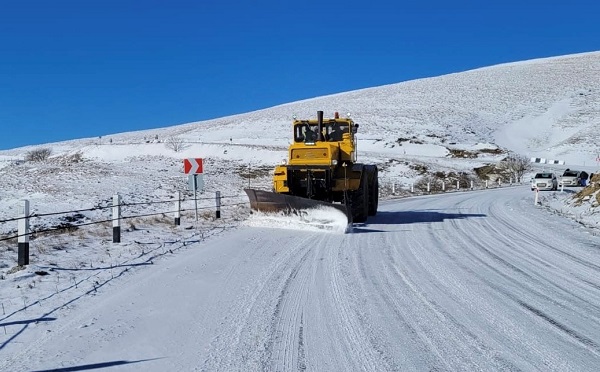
top-left (0, 187), bottom-right (600, 372)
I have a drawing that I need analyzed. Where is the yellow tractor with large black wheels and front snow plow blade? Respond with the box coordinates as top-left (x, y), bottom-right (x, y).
top-left (246, 111), bottom-right (379, 222)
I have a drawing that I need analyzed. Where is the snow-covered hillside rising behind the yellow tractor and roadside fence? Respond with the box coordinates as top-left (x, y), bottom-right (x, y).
top-left (0, 52), bottom-right (600, 233)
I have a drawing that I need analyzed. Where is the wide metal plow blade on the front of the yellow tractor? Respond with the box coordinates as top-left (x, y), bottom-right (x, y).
top-left (244, 189), bottom-right (352, 223)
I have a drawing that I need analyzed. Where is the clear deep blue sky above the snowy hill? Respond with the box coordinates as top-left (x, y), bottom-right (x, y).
top-left (0, 0), bottom-right (600, 150)
